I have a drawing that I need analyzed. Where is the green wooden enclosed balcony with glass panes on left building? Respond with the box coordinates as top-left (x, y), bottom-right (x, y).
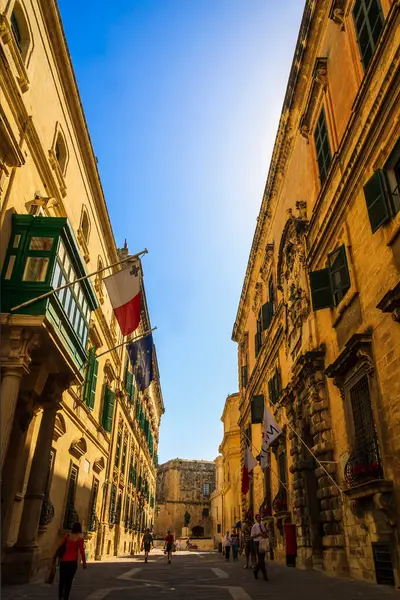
top-left (1, 215), bottom-right (98, 370)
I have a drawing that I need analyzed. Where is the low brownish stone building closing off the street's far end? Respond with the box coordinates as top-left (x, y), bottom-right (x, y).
top-left (154, 458), bottom-right (215, 538)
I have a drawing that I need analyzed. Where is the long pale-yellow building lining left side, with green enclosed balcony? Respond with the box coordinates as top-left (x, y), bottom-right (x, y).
top-left (0, 0), bottom-right (164, 582)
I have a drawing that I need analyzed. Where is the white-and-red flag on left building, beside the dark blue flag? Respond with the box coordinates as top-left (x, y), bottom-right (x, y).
top-left (104, 260), bottom-right (142, 336)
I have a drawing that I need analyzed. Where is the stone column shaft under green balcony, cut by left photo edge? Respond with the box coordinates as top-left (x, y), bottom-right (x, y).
top-left (0, 367), bottom-right (24, 472)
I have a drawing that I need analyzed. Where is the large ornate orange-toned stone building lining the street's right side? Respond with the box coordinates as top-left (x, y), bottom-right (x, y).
top-left (233, 0), bottom-right (400, 586)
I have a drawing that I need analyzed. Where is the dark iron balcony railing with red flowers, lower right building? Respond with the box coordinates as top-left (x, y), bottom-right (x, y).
top-left (344, 438), bottom-right (383, 487)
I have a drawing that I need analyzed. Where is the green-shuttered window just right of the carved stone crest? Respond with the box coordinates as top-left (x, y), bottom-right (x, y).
top-left (310, 244), bottom-right (350, 311)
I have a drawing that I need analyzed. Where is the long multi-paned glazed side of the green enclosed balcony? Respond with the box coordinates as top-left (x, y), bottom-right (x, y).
top-left (52, 240), bottom-right (91, 346)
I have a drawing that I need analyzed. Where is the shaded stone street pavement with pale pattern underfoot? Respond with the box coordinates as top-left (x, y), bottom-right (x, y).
top-left (1, 551), bottom-right (400, 600)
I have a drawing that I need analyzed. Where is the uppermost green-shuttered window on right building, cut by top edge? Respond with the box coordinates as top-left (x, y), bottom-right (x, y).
top-left (353, 0), bottom-right (384, 69)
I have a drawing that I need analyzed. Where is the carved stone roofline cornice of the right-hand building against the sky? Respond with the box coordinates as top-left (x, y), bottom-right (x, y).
top-left (232, 0), bottom-right (318, 342)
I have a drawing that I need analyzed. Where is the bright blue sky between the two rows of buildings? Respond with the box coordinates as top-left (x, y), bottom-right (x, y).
top-left (59, 0), bottom-right (304, 462)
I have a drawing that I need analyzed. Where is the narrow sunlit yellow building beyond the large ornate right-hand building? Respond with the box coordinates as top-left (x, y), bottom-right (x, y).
top-left (219, 393), bottom-right (242, 535)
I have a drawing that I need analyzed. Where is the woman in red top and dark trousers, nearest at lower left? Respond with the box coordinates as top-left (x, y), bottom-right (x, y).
top-left (53, 523), bottom-right (86, 600)
